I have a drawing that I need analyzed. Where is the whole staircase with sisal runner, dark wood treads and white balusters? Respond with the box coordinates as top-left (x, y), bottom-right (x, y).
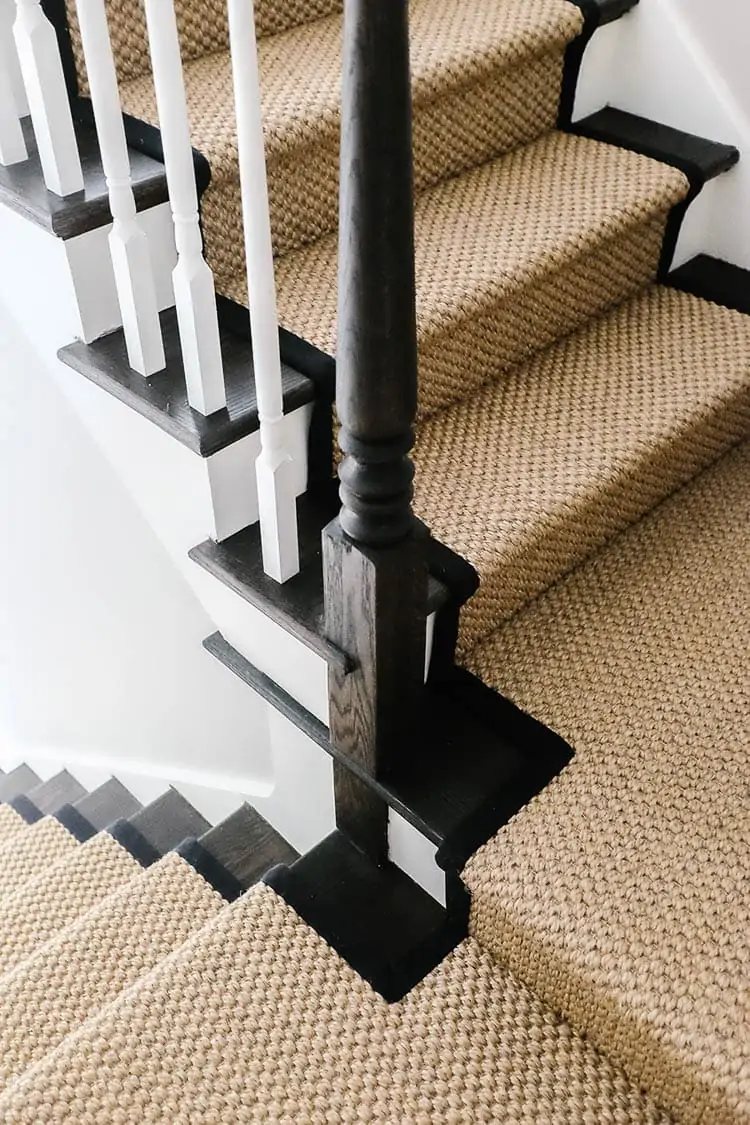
top-left (0, 0), bottom-right (750, 1125)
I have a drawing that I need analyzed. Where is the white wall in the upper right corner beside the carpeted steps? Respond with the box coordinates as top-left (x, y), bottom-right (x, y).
top-left (576, 0), bottom-right (750, 269)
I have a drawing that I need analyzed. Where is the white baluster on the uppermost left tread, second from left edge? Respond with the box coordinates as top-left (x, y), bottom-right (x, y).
top-left (13, 0), bottom-right (83, 196)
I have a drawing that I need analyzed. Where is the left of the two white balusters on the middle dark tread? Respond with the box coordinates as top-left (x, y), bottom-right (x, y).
top-left (76, 0), bottom-right (164, 376)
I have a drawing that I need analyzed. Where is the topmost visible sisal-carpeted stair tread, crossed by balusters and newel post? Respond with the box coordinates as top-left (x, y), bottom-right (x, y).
top-left (121, 0), bottom-right (582, 182)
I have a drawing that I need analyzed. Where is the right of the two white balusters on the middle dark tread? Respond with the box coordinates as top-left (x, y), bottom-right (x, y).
top-left (139, 0), bottom-right (226, 414)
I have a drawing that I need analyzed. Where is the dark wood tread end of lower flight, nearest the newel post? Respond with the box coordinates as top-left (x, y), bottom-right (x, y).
top-left (200, 804), bottom-right (299, 889)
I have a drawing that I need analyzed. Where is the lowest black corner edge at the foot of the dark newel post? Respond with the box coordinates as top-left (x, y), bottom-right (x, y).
top-left (263, 831), bottom-right (469, 1004)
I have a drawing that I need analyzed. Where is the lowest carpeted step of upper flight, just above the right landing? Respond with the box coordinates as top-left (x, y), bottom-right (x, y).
top-left (415, 286), bottom-right (750, 651)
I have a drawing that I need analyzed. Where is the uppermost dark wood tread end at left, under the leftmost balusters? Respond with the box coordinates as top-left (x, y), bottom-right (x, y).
top-left (0, 117), bottom-right (169, 239)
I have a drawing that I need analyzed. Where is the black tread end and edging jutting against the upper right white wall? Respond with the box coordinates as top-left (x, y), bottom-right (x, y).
top-left (568, 106), bottom-right (740, 280)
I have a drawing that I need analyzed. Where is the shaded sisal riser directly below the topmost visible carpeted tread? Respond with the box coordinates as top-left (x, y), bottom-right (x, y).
top-left (201, 52), bottom-right (562, 281)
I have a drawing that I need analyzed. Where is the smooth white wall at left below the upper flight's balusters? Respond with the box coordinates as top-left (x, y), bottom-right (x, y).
top-left (0, 302), bottom-right (275, 792)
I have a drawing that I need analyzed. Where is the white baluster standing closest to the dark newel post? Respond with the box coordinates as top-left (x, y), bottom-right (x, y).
top-left (228, 0), bottom-right (299, 582)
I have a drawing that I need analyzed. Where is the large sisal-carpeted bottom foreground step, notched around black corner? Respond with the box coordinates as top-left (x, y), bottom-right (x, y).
top-left (0, 885), bottom-right (668, 1125)
